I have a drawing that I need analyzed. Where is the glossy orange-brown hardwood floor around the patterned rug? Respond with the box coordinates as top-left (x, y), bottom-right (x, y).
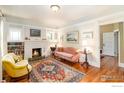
top-left (2, 56), bottom-right (124, 82)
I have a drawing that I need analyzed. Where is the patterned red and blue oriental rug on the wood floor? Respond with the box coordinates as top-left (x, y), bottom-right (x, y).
top-left (30, 59), bottom-right (85, 82)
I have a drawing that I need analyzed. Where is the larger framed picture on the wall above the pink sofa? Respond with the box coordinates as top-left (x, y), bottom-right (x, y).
top-left (66, 31), bottom-right (79, 43)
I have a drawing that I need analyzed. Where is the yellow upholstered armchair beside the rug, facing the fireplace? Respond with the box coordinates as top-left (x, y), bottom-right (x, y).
top-left (2, 53), bottom-right (32, 78)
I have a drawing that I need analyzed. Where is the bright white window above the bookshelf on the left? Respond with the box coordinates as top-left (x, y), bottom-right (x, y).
top-left (9, 26), bottom-right (22, 41)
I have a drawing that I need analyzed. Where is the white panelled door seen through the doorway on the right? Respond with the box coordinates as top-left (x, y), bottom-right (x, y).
top-left (103, 32), bottom-right (114, 56)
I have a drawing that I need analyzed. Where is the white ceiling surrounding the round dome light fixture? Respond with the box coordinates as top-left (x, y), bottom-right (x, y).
top-left (0, 5), bottom-right (124, 28)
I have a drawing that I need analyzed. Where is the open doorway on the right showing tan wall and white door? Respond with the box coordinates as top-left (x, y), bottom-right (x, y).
top-left (100, 23), bottom-right (120, 67)
